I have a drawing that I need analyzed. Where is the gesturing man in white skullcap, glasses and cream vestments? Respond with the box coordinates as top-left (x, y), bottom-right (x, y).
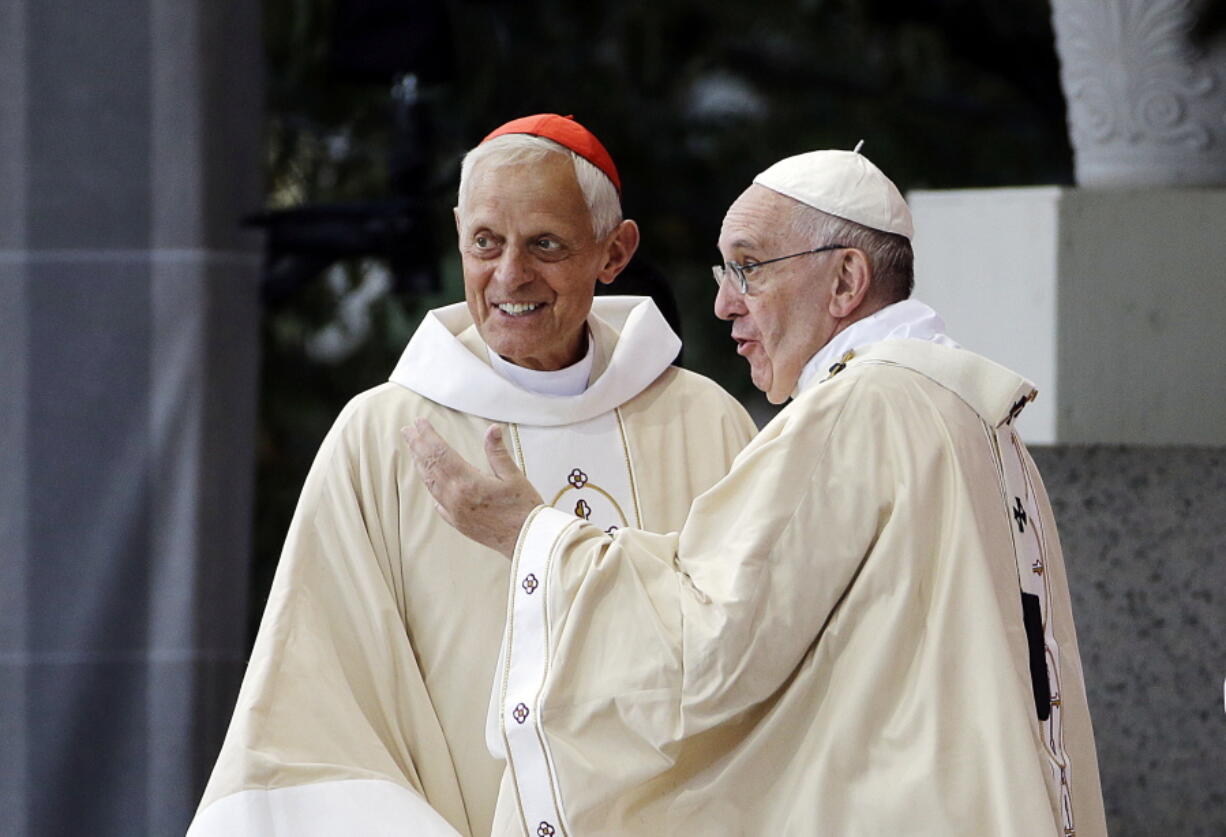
top-left (405, 151), bottom-right (1106, 837)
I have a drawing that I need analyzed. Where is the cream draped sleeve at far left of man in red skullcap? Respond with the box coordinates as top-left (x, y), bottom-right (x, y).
top-left (190, 394), bottom-right (467, 837)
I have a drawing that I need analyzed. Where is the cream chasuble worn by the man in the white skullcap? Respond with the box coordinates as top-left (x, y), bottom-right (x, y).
top-left (490, 355), bottom-right (1102, 837)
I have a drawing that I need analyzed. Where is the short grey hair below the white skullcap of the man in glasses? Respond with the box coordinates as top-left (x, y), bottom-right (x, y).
top-left (790, 201), bottom-right (915, 303)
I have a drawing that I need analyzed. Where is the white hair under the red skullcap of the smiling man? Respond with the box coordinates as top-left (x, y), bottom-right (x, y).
top-left (457, 134), bottom-right (622, 238)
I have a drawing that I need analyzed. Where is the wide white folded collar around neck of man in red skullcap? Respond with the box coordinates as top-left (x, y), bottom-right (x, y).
top-left (391, 297), bottom-right (682, 428)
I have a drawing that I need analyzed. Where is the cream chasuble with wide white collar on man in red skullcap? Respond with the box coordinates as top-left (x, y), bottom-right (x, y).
top-left (189, 297), bottom-right (754, 837)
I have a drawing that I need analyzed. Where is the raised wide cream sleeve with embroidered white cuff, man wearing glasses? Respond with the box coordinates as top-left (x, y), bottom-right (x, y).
top-left (492, 377), bottom-right (891, 831)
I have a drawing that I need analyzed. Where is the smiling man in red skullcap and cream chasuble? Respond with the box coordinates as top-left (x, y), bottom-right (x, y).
top-left (189, 114), bottom-right (754, 837)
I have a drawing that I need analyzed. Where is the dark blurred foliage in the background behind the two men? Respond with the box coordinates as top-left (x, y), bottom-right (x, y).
top-left (254, 0), bottom-right (1072, 627)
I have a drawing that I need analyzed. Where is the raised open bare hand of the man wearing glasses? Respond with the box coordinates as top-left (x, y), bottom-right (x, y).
top-left (401, 419), bottom-right (543, 558)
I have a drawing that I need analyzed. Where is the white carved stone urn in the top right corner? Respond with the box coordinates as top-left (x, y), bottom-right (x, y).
top-left (1052, 0), bottom-right (1226, 186)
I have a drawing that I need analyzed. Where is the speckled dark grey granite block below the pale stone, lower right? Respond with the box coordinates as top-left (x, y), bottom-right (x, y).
top-left (1031, 445), bottom-right (1226, 837)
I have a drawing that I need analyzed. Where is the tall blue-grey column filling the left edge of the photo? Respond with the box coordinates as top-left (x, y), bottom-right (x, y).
top-left (0, 0), bottom-right (262, 837)
